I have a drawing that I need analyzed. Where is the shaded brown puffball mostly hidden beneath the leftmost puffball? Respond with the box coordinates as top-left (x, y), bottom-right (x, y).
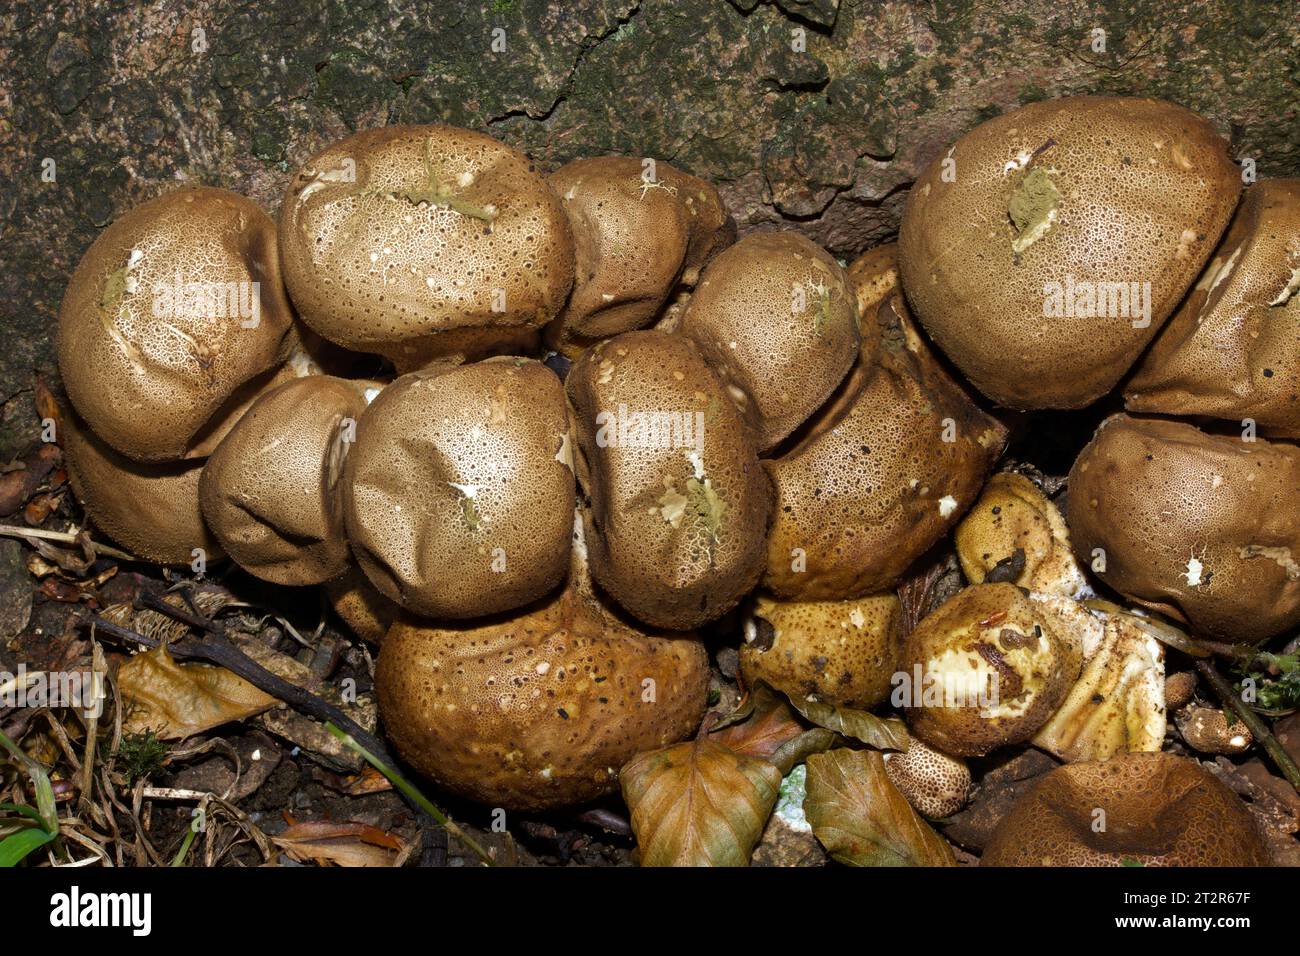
top-left (59, 408), bottom-right (222, 564)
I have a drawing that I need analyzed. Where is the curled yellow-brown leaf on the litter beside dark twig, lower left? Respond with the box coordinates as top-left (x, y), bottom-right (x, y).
top-left (117, 645), bottom-right (277, 739)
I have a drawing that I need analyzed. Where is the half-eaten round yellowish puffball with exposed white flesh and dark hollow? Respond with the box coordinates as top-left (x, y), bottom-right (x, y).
top-left (894, 584), bottom-right (1082, 757)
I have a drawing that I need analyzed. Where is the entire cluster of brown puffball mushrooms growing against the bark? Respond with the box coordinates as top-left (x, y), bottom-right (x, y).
top-left (59, 98), bottom-right (1300, 864)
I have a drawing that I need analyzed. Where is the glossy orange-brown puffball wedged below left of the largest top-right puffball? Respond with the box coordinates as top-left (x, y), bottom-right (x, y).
top-left (763, 291), bottom-right (1006, 600)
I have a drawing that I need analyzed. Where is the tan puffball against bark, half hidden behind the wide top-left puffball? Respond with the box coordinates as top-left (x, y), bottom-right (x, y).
top-left (547, 156), bottom-right (736, 358)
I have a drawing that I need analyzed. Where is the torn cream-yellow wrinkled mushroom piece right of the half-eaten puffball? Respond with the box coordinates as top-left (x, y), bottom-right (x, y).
top-left (1034, 606), bottom-right (1166, 762)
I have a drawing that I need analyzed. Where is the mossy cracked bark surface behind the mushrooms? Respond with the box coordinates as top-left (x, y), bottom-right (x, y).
top-left (0, 0), bottom-right (1300, 462)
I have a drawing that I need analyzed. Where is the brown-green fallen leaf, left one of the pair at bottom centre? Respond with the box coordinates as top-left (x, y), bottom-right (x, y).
top-left (620, 740), bottom-right (781, 866)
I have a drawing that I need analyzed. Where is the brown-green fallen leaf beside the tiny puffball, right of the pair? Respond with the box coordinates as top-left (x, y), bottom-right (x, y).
top-left (803, 749), bottom-right (957, 866)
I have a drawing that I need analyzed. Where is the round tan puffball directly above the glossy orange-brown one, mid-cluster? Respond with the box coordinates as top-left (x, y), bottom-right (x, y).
top-left (677, 232), bottom-right (880, 454)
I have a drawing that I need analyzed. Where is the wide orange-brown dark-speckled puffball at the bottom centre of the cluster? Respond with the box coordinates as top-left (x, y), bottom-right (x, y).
top-left (374, 556), bottom-right (709, 810)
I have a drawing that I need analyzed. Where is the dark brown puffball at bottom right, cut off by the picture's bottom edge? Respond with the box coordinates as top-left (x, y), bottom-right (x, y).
top-left (980, 753), bottom-right (1270, 866)
